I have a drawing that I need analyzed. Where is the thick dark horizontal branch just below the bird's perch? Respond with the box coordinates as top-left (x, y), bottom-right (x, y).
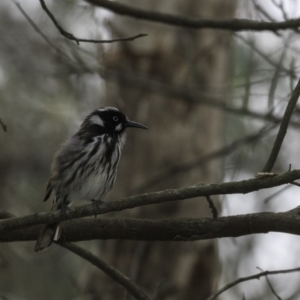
top-left (0, 207), bottom-right (300, 242)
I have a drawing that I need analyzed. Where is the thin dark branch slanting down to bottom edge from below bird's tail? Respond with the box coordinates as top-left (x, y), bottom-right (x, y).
top-left (58, 243), bottom-right (151, 300)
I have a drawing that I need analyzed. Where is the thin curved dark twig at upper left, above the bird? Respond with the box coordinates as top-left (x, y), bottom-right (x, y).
top-left (40, 0), bottom-right (148, 45)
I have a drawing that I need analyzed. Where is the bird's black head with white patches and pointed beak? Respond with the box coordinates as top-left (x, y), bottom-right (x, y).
top-left (81, 106), bottom-right (148, 135)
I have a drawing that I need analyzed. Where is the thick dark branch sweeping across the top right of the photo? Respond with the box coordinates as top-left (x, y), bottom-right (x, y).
top-left (86, 0), bottom-right (300, 31)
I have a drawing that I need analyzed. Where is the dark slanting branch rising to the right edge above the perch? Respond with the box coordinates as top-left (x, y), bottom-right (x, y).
top-left (262, 79), bottom-right (300, 172)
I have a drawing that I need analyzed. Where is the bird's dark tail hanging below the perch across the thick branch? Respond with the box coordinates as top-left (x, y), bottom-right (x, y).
top-left (34, 203), bottom-right (61, 253)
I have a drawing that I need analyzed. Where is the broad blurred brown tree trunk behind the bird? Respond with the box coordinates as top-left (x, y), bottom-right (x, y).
top-left (88, 0), bottom-right (235, 300)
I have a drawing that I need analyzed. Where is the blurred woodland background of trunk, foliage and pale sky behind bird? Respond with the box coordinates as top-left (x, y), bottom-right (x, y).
top-left (0, 0), bottom-right (300, 300)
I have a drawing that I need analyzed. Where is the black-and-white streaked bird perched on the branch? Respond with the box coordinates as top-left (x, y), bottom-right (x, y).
top-left (34, 106), bottom-right (148, 253)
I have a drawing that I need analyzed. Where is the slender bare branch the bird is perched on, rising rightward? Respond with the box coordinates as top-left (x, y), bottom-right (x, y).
top-left (0, 170), bottom-right (300, 233)
